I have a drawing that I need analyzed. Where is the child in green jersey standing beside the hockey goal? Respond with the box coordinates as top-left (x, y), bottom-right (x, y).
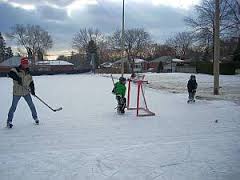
top-left (112, 77), bottom-right (126, 114)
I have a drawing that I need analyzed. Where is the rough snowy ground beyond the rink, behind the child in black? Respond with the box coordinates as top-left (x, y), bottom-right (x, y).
top-left (111, 73), bottom-right (240, 104)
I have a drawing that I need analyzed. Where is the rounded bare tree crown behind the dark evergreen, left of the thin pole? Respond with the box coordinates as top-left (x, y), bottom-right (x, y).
top-left (72, 28), bottom-right (102, 53)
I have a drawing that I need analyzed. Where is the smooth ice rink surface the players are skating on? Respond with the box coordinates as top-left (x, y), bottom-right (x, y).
top-left (0, 74), bottom-right (240, 180)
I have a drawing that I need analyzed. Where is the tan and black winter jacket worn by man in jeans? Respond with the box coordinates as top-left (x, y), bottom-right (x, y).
top-left (8, 66), bottom-right (35, 96)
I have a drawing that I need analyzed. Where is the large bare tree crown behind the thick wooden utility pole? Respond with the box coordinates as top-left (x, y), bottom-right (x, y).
top-left (185, 0), bottom-right (240, 43)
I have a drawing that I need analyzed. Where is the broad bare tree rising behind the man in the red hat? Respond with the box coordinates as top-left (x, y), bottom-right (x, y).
top-left (8, 24), bottom-right (53, 64)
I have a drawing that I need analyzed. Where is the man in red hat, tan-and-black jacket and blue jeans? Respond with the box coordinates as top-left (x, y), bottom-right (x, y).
top-left (7, 57), bottom-right (39, 128)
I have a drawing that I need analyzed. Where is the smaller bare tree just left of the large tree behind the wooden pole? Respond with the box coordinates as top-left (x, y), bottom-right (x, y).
top-left (166, 32), bottom-right (193, 59)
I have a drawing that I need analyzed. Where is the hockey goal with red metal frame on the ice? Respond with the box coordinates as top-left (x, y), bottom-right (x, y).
top-left (127, 76), bottom-right (155, 116)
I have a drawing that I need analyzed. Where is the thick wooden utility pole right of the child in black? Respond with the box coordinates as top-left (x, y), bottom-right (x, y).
top-left (213, 0), bottom-right (220, 95)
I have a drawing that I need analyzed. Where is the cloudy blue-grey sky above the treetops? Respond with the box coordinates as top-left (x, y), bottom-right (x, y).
top-left (0, 0), bottom-right (200, 59)
